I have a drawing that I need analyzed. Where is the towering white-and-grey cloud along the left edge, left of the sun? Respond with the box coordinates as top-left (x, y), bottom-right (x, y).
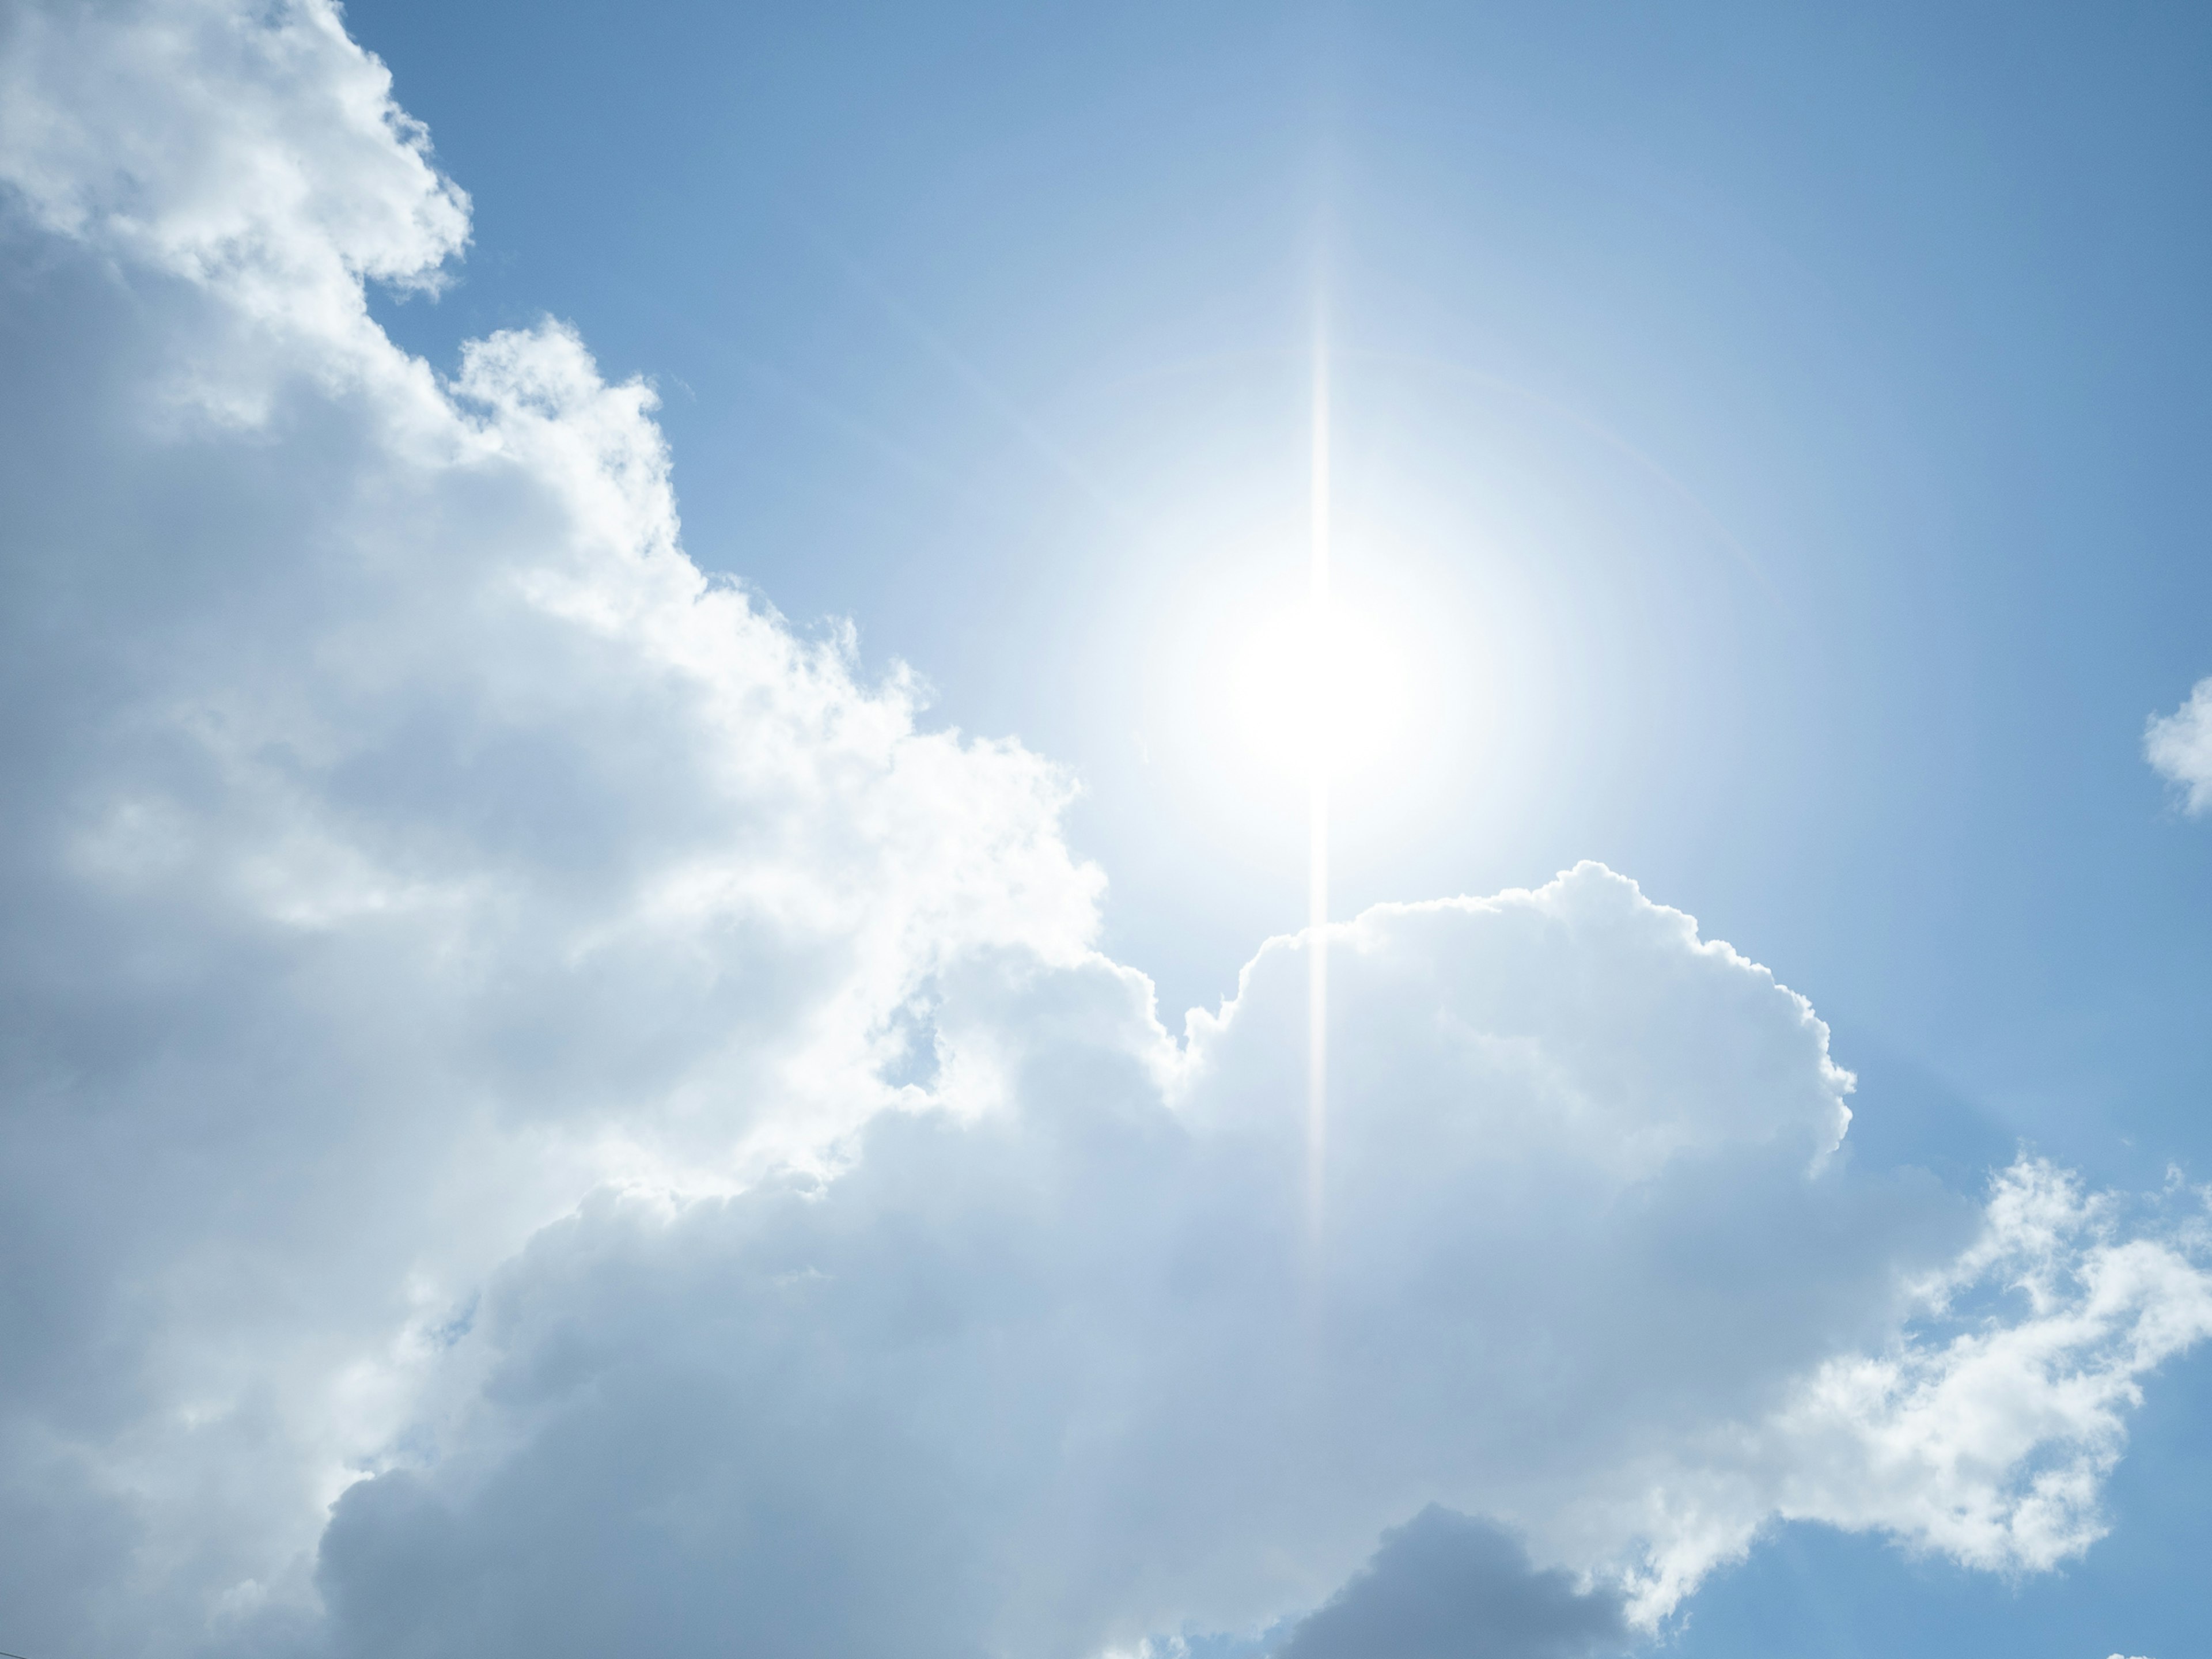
top-left (0, 5), bottom-right (1097, 1652)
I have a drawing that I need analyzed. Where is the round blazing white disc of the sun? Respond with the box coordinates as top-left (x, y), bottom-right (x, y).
top-left (1230, 604), bottom-right (1409, 777)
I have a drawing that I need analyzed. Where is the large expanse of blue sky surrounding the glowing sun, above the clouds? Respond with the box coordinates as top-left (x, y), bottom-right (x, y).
top-left (350, 5), bottom-right (2212, 1132)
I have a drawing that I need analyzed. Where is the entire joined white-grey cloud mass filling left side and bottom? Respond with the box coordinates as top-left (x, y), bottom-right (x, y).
top-left (0, 0), bottom-right (2212, 1659)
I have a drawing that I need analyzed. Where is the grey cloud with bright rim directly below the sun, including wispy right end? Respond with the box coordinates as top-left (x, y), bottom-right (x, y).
top-left (294, 865), bottom-right (2212, 1654)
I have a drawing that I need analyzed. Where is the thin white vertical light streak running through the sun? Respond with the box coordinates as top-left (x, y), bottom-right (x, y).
top-left (1305, 332), bottom-right (1338, 1241)
